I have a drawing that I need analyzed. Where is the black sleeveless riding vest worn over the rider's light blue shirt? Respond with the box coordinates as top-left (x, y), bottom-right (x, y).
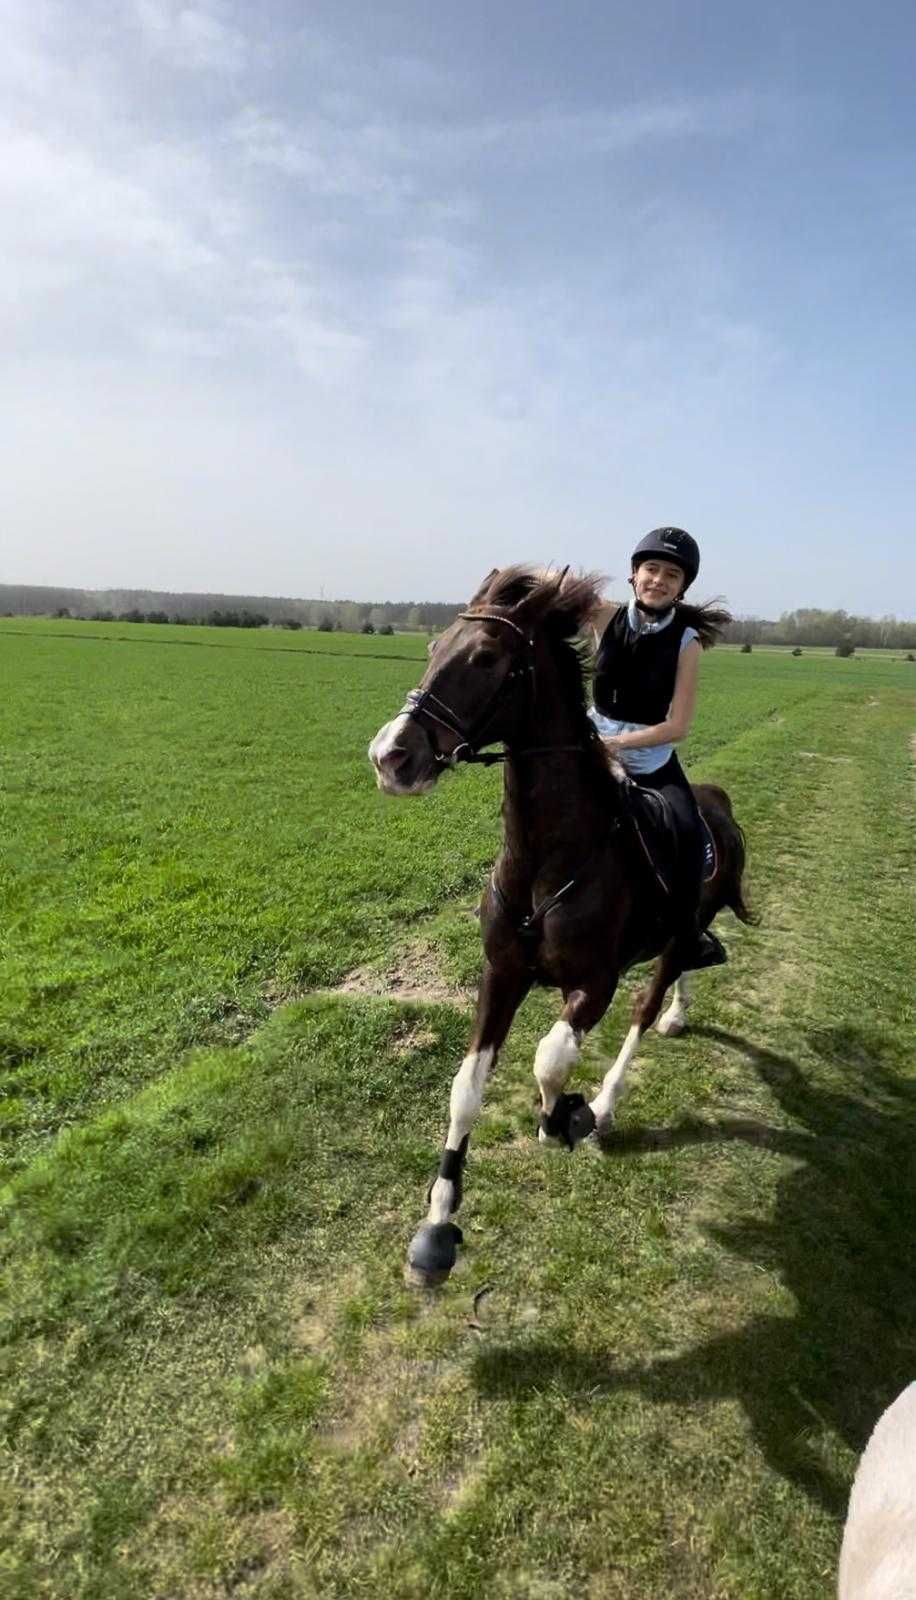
top-left (593, 605), bottom-right (690, 726)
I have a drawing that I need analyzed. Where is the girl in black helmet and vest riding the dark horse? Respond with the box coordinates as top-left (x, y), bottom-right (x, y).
top-left (591, 528), bottom-right (730, 970)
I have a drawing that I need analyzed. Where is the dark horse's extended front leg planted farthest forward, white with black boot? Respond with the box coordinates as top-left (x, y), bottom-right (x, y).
top-left (407, 962), bottom-right (532, 1288)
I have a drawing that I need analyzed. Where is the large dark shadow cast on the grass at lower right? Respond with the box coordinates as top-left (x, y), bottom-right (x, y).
top-left (474, 1027), bottom-right (916, 1515)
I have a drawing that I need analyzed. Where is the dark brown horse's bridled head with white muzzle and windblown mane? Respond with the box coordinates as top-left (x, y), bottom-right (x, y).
top-left (368, 566), bottom-right (599, 795)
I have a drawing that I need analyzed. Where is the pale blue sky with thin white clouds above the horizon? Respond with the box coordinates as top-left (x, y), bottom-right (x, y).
top-left (0, 0), bottom-right (916, 618)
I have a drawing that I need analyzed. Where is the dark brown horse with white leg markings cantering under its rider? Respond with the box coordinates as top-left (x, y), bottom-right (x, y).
top-left (368, 566), bottom-right (749, 1286)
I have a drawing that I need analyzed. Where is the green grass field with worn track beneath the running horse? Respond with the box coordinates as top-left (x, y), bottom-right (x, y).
top-left (0, 619), bottom-right (916, 1600)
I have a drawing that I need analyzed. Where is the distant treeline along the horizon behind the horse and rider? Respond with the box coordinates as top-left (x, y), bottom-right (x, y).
top-left (0, 584), bottom-right (916, 650)
